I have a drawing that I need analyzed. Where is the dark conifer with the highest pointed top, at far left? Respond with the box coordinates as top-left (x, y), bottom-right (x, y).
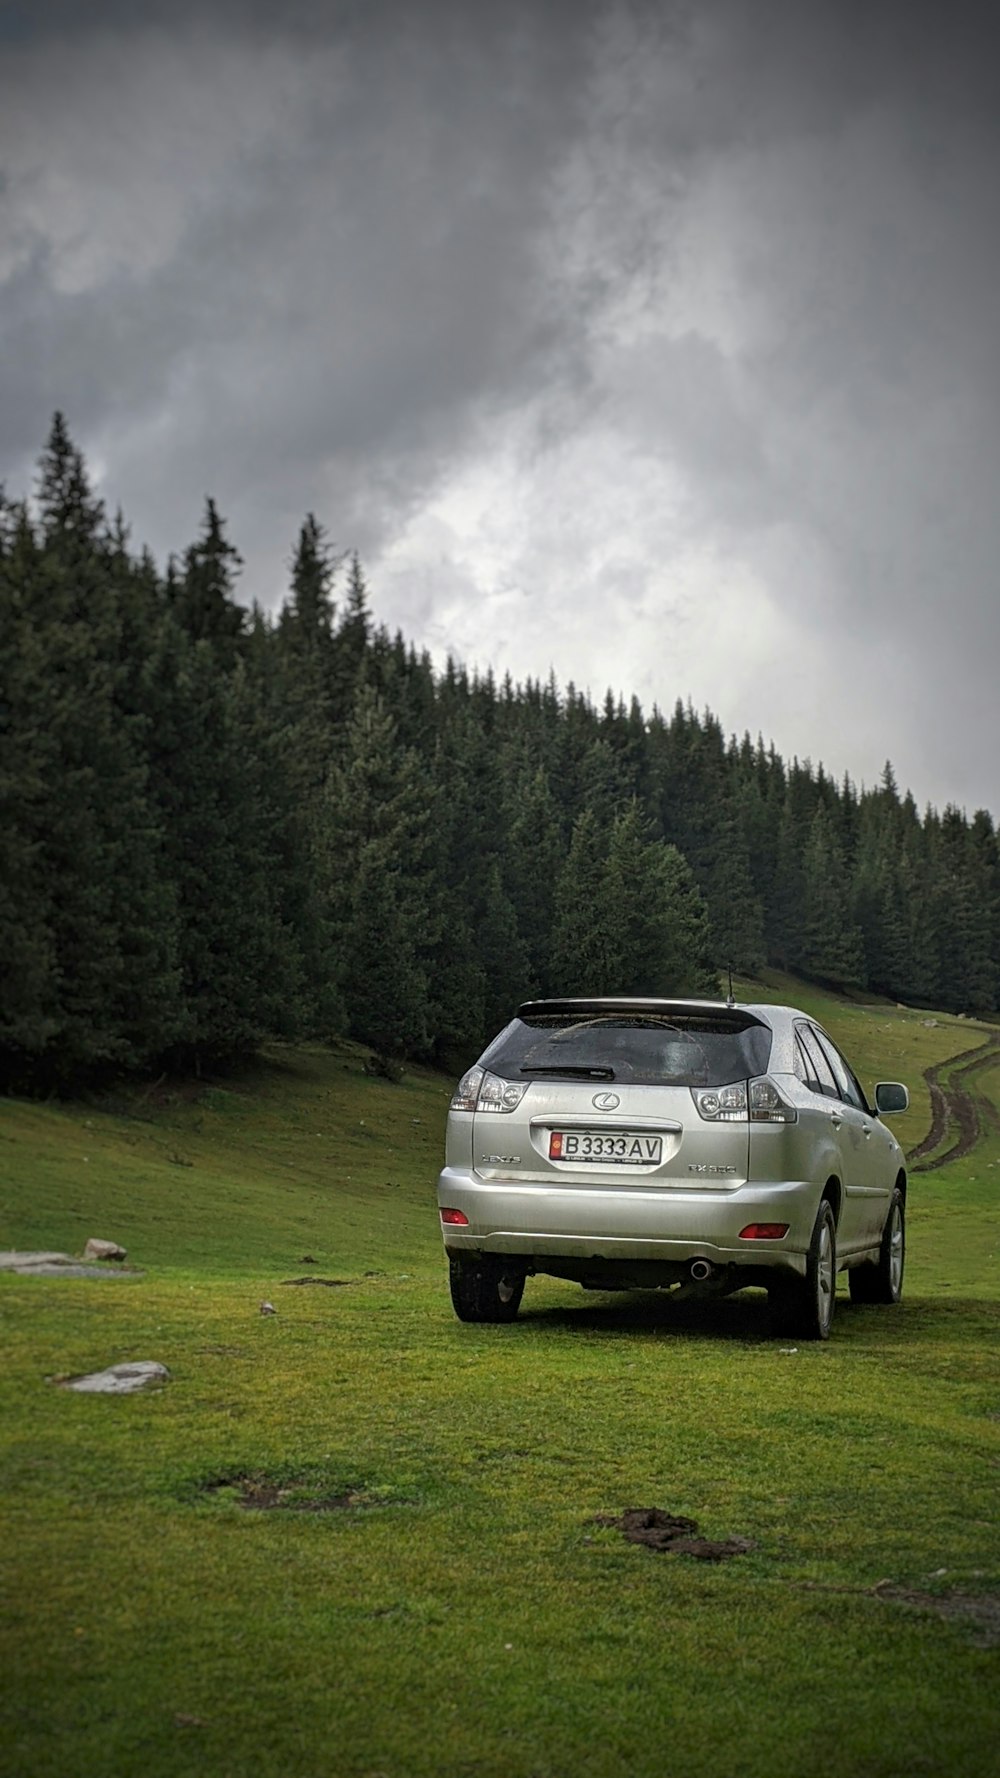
top-left (4, 414), bottom-right (176, 1083)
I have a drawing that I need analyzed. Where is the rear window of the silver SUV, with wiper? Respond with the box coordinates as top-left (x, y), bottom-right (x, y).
top-left (482, 1012), bottom-right (770, 1086)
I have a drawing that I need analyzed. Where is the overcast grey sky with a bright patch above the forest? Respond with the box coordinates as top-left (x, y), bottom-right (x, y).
top-left (0, 0), bottom-right (1000, 814)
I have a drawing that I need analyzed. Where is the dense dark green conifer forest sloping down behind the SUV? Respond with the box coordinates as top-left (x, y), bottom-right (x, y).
top-left (0, 414), bottom-right (1000, 1090)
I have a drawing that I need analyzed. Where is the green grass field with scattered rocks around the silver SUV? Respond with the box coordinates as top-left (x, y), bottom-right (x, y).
top-left (0, 976), bottom-right (1000, 1778)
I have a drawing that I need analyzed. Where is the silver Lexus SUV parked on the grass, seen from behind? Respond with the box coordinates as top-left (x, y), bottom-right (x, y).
top-left (438, 997), bottom-right (909, 1339)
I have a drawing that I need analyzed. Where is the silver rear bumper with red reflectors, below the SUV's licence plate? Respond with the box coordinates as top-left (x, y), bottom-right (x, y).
top-left (438, 1168), bottom-right (820, 1275)
